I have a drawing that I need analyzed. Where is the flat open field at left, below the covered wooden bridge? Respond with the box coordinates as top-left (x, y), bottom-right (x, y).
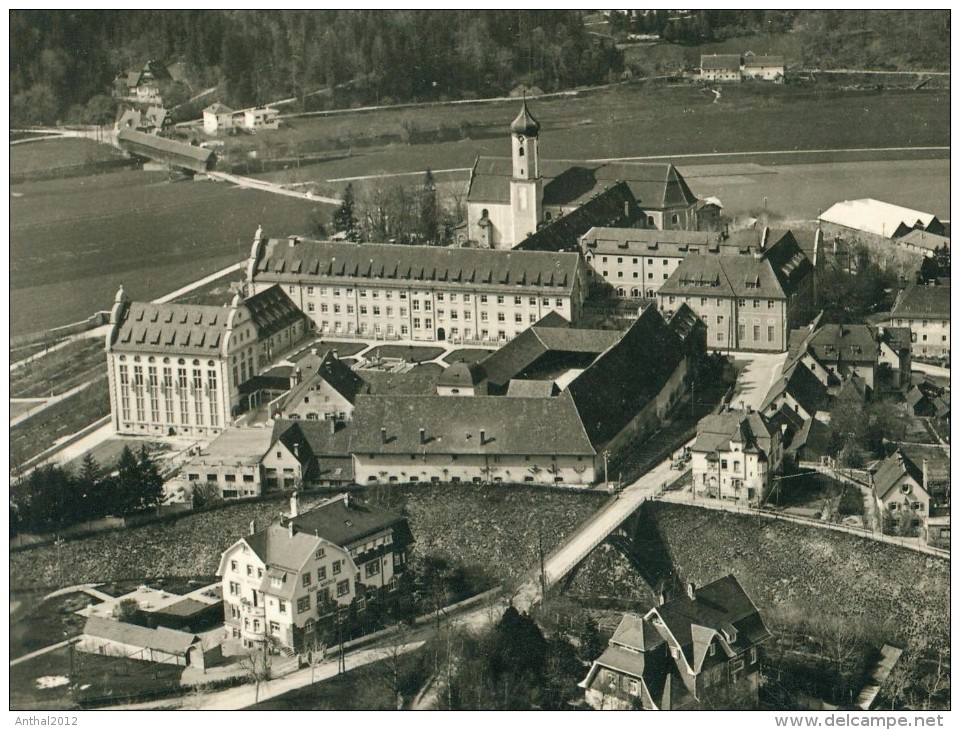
top-left (10, 170), bottom-right (329, 335)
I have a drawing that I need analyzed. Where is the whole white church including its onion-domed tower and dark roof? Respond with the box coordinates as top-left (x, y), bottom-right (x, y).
top-left (467, 102), bottom-right (698, 250)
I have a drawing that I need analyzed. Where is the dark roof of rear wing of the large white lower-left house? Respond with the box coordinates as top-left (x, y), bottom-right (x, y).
top-left (291, 497), bottom-right (413, 549)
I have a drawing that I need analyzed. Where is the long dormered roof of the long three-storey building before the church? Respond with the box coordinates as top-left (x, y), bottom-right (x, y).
top-left (254, 239), bottom-right (579, 292)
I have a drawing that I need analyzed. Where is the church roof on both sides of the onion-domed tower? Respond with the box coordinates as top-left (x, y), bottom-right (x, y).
top-left (467, 157), bottom-right (697, 210)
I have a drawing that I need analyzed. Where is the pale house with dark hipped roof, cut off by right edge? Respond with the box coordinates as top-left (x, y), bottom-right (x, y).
top-left (888, 279), bottom-right (950, 361)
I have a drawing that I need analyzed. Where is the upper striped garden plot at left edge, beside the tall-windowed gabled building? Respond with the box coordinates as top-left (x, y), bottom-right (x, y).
top-left (10, 337), bottom-right (107, 398)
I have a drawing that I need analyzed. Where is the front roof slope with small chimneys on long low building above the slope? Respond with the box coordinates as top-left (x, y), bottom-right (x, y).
top-left (351, 393), bottom-right (595, 456)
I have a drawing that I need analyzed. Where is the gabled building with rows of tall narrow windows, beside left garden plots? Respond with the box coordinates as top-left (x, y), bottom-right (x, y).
top-left (105, 287), bottom-right (310, 436)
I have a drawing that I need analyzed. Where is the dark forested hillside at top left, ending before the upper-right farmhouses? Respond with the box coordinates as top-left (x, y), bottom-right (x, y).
top-left (10, 10), bottom-right (622, 122)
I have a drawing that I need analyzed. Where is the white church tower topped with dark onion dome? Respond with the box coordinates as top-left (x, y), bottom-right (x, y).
top-left (504, 99), bottom-right (543, 247)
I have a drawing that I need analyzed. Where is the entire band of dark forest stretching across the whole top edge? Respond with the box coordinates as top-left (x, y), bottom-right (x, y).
top-left (10, 10), bottom-right (950, 124)
